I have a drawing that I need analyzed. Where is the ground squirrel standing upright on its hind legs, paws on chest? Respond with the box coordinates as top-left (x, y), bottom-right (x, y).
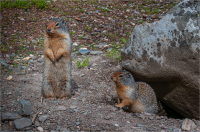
top-left (42, 18), bottom-right (71, 98)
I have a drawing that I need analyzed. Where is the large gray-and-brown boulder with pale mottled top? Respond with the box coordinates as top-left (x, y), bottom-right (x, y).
top-left (121, 0), bottom-right (200, 119)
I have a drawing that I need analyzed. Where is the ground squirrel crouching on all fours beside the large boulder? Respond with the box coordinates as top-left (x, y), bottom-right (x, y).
top-left (111, 70), bottom-right (158, 114)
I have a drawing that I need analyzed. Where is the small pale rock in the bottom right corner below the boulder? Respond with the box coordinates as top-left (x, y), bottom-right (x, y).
top-left (181, 119), bottom-right (196, 131)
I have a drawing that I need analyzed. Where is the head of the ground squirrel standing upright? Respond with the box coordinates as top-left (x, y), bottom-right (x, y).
top-left (46, 17), bottom-right (66, 37)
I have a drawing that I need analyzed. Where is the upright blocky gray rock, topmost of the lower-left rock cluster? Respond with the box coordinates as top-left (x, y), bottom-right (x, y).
top-left (19, 99), bottom-right (32, 116)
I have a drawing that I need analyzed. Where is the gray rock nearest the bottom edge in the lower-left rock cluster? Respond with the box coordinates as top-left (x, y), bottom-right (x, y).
top-left (14, 118), bottom-right (32, 130)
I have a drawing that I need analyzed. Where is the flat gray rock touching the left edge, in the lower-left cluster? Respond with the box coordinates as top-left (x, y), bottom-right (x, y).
top-left (1, 112), bottom-right (21, 121)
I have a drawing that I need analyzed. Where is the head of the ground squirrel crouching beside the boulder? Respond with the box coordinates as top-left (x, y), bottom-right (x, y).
top-left (111, 70), bottom-right (135, 85)
